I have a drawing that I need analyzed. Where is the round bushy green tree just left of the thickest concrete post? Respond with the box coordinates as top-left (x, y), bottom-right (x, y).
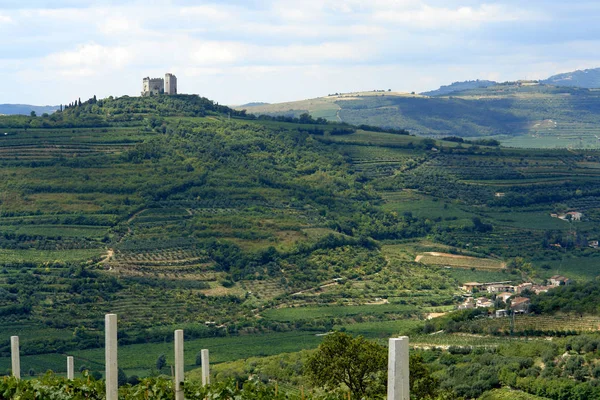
top-left (305, 332), bottom-right (387, 399)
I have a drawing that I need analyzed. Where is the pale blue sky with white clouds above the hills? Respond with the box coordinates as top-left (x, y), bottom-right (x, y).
top-left (0, 0), bottom-right (600, 105)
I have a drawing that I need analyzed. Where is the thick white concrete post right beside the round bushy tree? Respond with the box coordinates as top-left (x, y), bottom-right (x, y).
top-left (387, 336), bottom-right (410, 400)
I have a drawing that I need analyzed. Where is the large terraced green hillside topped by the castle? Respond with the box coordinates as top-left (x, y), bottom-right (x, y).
top-left (0, 93), bottom-right (600, 382)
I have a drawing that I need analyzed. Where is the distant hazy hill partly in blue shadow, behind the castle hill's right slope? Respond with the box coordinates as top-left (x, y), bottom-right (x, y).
top-left (240, 82), bottom-right (600, 148)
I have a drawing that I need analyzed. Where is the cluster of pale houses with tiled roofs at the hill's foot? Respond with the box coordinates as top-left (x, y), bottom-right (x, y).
top-left (458, 275), bottom-right (571, 317)
